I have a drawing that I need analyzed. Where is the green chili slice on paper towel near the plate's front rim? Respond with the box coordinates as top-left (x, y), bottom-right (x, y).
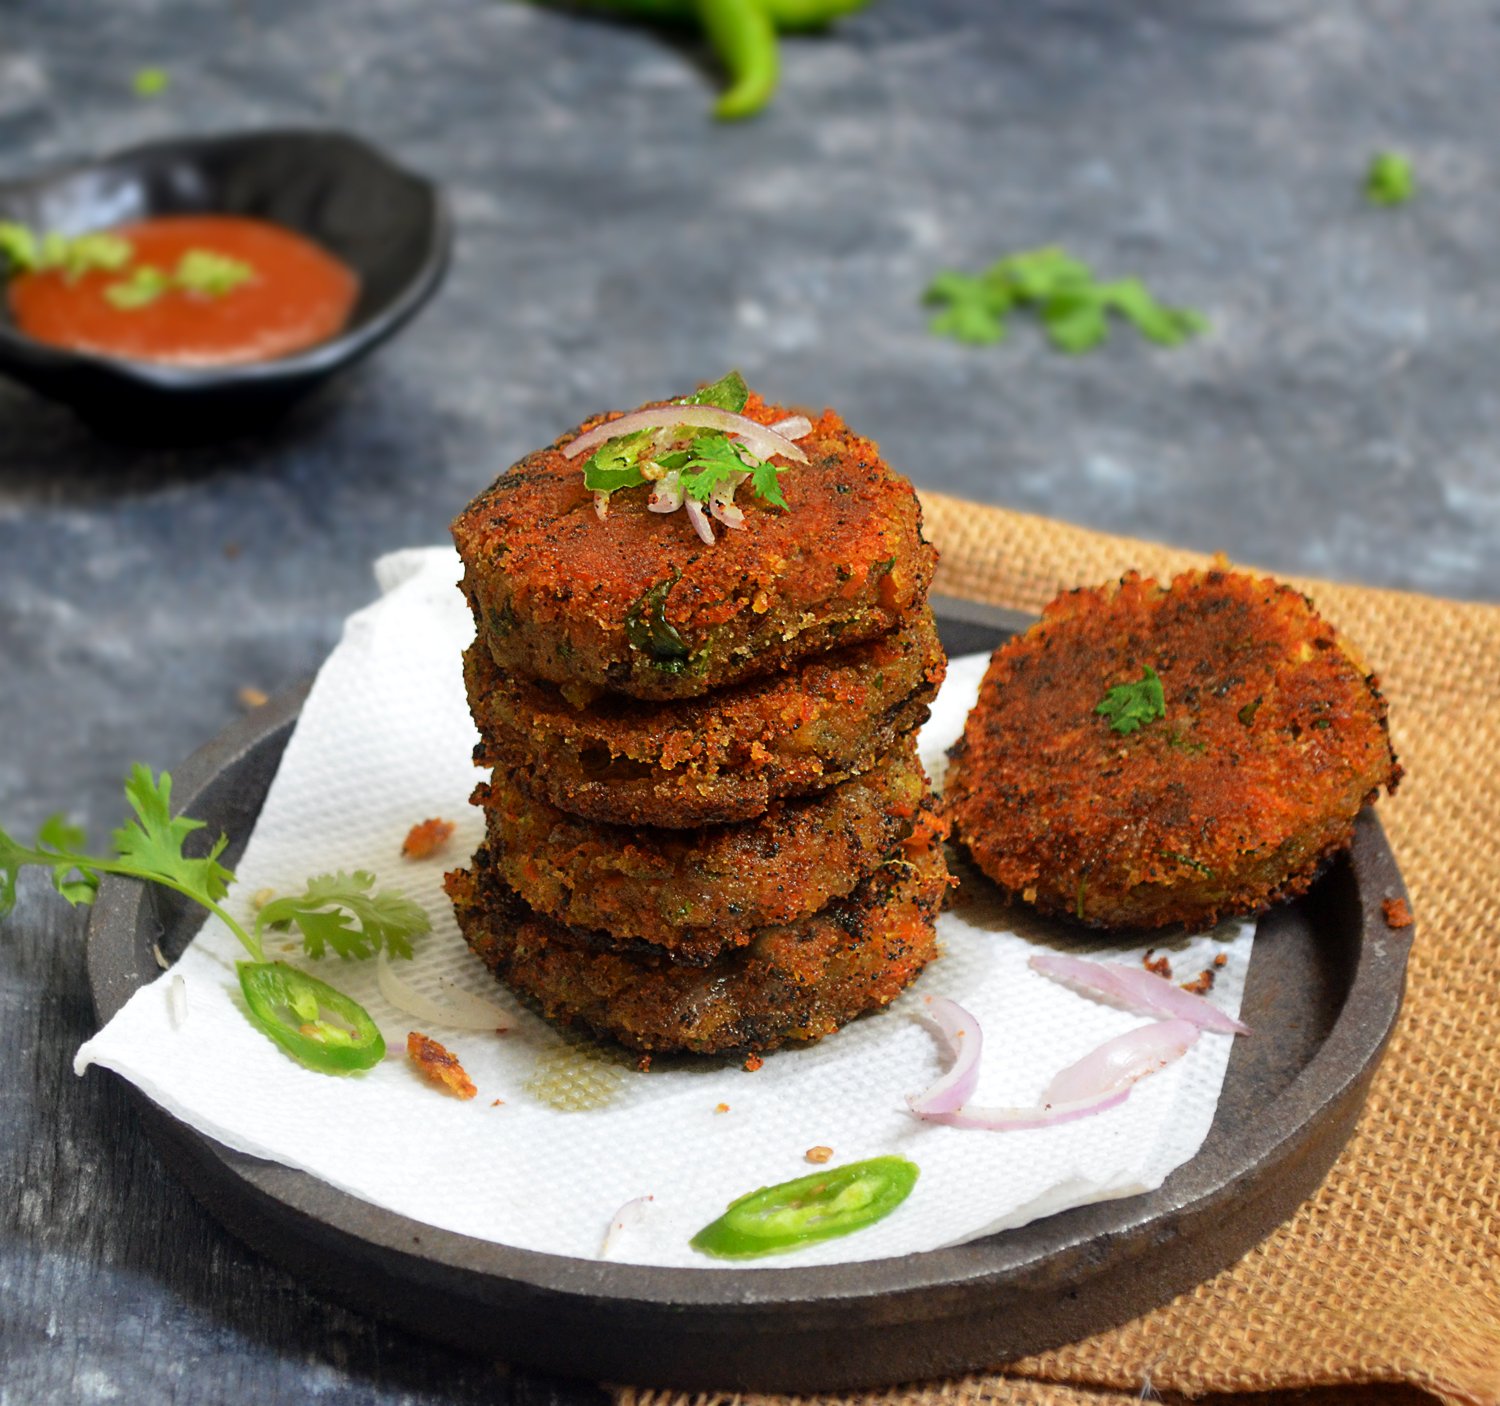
top-left (692, 1157), bottom-right (918, 1259)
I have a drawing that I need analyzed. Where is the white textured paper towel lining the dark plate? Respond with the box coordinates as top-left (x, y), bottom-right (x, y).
top-left (77, 548), bottom-right (1254, 1266)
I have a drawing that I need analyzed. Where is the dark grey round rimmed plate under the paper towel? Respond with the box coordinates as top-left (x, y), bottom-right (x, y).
top-left (89, 602), bottom-right (1413, 1392)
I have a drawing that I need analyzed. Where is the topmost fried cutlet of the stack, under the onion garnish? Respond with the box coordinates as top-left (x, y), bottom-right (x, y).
top-left (453, 395), bottom-right (936, 698)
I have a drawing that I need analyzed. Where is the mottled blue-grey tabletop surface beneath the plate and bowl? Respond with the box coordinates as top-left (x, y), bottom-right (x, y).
top-left (0, 0), bottom-right (1500, 1406)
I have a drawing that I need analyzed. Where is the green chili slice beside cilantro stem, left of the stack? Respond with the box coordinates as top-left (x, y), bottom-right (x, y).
top-left (237, 962), bottom-right (386, 1074)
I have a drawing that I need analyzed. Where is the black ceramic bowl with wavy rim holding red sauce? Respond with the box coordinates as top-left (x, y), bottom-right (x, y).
top-left (0, 131), bottom-right (452, 441)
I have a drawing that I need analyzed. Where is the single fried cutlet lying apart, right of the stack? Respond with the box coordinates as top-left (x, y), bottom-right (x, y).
top-left (945, 569), bottom-right (1401, 927)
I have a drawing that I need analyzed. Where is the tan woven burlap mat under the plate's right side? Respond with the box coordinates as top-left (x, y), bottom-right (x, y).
top-left (618, 494), bottom-right (1500, 1406)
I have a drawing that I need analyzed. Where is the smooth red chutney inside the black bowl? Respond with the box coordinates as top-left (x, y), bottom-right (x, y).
top-left (11, 215), bottom-right (360, 366)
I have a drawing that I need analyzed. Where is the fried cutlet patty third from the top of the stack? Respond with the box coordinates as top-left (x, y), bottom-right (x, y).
top-left (474, 738), bottom-right (927, 962)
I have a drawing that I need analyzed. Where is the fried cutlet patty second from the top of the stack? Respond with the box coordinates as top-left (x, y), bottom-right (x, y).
top-left (464, 606), bottom-right (947, 828)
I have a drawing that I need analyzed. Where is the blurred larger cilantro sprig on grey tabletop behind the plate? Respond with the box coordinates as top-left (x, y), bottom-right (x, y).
top-left (924, 248), bottom-right (1208, 353)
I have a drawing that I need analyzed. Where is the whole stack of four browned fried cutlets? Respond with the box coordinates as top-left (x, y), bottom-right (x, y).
top-left (449, 395), bottom-right (948, 1053)
